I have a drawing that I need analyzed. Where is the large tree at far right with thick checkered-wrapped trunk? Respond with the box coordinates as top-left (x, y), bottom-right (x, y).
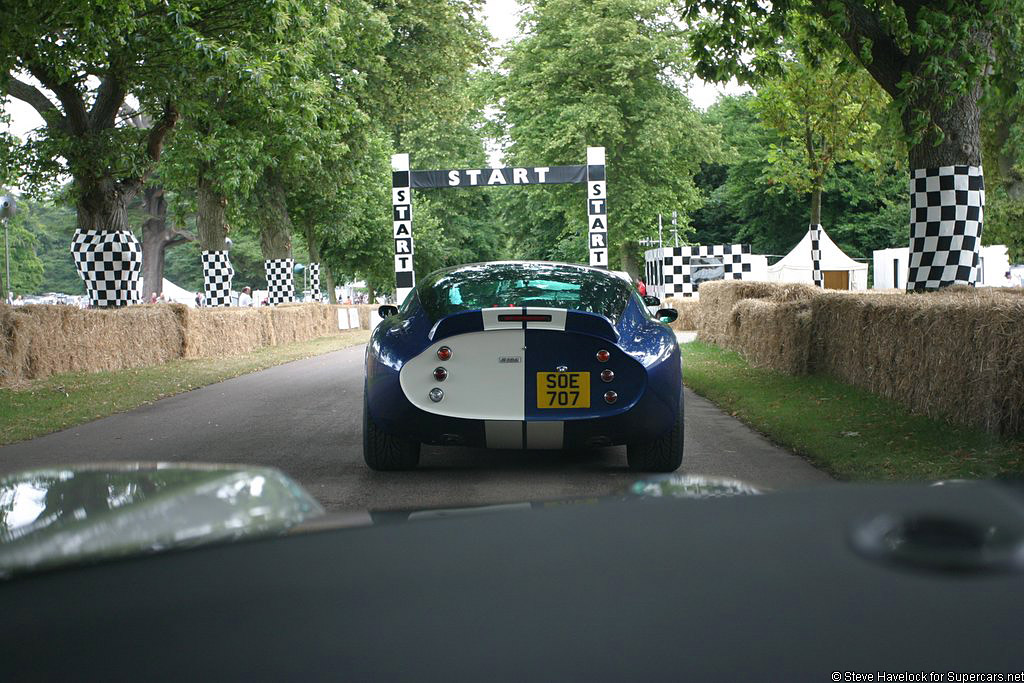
top-left (679, 0), bottom-right (1024, 290)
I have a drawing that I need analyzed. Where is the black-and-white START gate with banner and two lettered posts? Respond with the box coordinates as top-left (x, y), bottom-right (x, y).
top-left (391, 147), bottom-right (608, 304)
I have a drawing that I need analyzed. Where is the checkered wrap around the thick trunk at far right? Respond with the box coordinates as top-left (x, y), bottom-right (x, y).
top-left (906, 166), bottom-right (985, 291)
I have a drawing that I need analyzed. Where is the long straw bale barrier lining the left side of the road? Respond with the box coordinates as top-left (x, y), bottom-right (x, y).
top-left (0, 303), bottom-right (362, 387)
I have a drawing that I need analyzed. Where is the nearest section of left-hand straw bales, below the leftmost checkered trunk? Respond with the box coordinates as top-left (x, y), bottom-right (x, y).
top-left (0, 304), bottom-right (185, 386)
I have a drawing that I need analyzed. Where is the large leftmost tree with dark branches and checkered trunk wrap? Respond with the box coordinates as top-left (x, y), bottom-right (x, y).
top-left (0, 0), bottom-right (284, 305)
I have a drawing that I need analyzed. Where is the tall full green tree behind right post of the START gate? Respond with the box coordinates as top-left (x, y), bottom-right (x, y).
top-left (498, 0), bottom-right (715, 273)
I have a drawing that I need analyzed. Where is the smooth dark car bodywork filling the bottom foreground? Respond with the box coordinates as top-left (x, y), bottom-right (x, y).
top-left (0, 482), bottom-right (1024, 681)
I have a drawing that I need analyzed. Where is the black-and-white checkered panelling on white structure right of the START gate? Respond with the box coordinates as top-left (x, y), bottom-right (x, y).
top-left (644, 245), bottom-right (753, 299)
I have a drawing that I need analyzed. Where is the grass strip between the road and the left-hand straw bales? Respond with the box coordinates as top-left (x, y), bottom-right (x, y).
top-left (0, 330), bottom-right (370, 445)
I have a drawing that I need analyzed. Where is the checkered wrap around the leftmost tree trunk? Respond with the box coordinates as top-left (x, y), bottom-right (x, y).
top-left (71, 229), bottom-right (142, 308)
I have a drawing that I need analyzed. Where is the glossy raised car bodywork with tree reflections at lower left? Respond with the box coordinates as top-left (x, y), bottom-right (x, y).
top-left (0, 463), bottom-right (324, 578)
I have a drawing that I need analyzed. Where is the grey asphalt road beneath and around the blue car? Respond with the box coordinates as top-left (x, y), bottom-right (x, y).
top-left (0, 346), bottom-right (830, 511)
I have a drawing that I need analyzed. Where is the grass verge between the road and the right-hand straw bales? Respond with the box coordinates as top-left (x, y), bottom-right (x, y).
top-left (682, 342), bottom-right (1024, 480)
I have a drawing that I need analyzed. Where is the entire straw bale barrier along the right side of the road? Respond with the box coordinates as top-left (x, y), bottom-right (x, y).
top-left (697, 282), bottom-right (1024, 435)
